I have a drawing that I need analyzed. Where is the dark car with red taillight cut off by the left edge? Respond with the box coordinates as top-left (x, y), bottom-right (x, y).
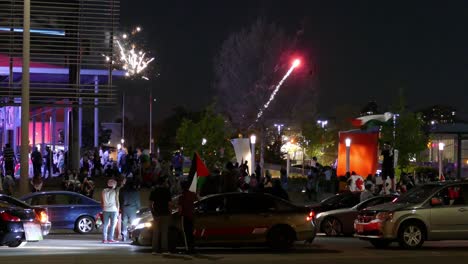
top-left (0, 195), bottom-right (43, 247)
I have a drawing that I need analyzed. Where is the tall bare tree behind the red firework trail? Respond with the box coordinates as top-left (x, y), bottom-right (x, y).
top-left (214, 18), bottom-right (316, 170)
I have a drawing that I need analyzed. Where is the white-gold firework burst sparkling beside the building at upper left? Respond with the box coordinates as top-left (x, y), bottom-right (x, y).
top-left (103, 27), bottom-right (154, 80)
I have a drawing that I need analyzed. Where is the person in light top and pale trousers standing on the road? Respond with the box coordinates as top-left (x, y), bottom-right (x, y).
top-left (101, 179), bottom-right (119, 243)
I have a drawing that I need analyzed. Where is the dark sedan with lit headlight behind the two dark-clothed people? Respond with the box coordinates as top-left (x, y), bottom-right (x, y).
top-left (130, 193), bottom-right (316, 249)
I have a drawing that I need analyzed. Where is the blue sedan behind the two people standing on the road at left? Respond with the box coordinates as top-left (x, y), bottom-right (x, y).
top-left (20, 191), bottom-right (102, 234)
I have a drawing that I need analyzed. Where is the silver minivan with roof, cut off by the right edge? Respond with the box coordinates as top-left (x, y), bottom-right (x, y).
top-left (354, 181), bottom-right (468, 249)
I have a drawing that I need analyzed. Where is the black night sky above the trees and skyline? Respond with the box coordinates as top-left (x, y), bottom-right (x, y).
top-left (115, 0), bottom-right (468, 124)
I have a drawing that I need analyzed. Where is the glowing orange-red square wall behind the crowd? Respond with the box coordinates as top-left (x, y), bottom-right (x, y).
top-left (337, 130), bottom-right (379, 177)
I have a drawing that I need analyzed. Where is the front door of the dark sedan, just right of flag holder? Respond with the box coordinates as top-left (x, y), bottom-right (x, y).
top-left (194, 195), bottom-right (226, 243)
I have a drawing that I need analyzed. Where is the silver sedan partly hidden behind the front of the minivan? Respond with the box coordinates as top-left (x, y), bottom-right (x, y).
top-left (315, 195), bottom-right (398, 236)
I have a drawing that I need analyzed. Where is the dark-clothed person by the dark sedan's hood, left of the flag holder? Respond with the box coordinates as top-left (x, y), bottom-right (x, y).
top-left (150, 177), bottom-right (171, 254)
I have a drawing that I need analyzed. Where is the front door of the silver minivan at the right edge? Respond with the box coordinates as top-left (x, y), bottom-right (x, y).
top-left (430, 184), bottom-right (468, 239)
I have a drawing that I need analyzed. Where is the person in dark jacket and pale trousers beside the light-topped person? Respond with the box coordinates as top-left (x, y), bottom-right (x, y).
top-left (119, 179), bottom-right (141, 242)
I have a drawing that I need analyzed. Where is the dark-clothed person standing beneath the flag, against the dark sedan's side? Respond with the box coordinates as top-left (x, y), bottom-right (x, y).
top-left (178, 181), bottom-right (198, 254)
